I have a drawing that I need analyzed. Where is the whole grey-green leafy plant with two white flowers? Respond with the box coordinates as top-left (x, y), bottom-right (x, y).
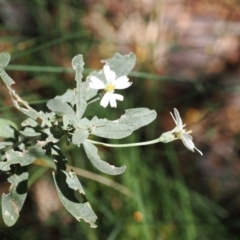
top-left (0, 52), bottom-right (202, 227)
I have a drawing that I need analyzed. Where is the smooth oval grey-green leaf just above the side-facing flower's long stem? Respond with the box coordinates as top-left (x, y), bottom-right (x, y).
top-left (91, 122), bottom-right (132, 139)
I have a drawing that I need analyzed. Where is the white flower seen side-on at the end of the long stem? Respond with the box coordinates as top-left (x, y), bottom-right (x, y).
top-left (170, 108), bottom-right (203, 155)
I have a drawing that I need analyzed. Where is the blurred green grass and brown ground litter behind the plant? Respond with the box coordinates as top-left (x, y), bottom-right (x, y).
top-left (0, 0), bottom-right (240, 240)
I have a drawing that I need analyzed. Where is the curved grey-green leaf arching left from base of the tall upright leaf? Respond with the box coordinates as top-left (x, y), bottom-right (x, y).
top-left (47, 98), bottom-right (78, 127)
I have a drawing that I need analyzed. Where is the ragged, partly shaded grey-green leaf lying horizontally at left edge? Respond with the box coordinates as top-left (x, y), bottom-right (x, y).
top-left (0, 144), bottom-right (45, 171)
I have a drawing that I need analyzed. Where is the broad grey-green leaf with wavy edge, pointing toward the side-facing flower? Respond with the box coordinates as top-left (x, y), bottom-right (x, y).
top-left (117, 108), bottom-right (157, 131)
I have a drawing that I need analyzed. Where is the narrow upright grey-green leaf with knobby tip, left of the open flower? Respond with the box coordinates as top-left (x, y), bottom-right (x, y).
top-left (72, 54), bottom-right (87, 119)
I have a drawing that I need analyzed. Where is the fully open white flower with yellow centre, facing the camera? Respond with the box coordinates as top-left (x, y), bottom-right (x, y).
top-left (89, 65), bottom-right (132, 107)
